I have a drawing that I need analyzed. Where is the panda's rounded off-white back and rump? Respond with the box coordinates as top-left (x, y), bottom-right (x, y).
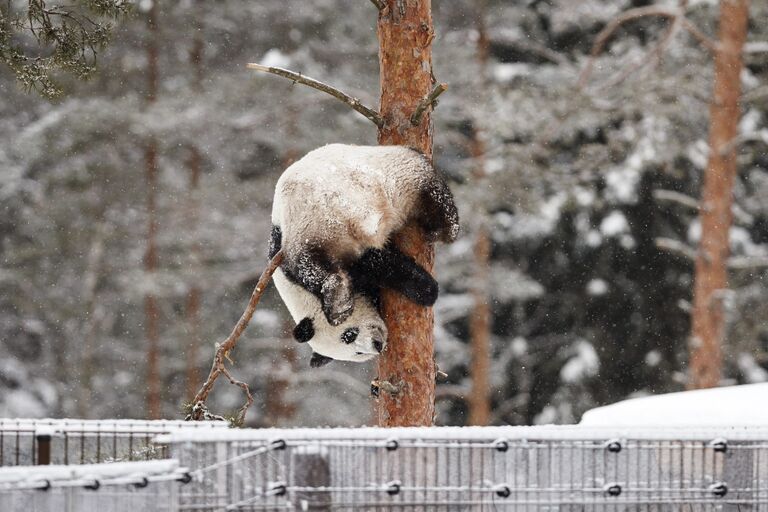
top-left (272, 144), bottom-right (434, 259)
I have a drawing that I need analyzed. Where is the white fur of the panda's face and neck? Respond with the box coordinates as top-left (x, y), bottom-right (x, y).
top-left (272, 268), bottom-right (387, 362)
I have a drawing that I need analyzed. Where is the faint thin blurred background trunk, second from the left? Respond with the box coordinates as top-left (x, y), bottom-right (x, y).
top-left (183, 15), bottom-right (203, 400)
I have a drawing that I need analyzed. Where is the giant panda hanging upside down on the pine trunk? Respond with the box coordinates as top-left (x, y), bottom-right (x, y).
top-left (269, 144), bottom-right (459, 367)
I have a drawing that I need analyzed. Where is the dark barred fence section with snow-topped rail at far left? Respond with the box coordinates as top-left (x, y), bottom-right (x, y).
top-left (0, 418), bottom-right (228, 467)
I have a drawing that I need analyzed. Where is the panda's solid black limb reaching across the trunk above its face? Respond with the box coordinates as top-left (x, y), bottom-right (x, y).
top-left (350, 243), bottom-right (438, 306)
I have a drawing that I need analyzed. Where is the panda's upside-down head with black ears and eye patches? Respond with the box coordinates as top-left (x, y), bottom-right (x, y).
top-left (293, 295), bottom-right (387, 368)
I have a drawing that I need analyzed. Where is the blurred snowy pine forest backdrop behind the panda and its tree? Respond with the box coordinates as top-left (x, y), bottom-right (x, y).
top-left (0, 0), bottom-right (768, 426)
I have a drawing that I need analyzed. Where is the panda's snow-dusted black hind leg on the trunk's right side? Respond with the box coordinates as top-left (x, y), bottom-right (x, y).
top-left (417, 171), bottom-right (459, 243)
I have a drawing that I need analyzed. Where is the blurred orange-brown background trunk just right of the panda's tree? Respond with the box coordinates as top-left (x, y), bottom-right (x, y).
top-left (469, 0), bottom-right (491, 425)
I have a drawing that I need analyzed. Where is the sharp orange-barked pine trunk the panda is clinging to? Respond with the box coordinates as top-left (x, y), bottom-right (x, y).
top-left (378, 0), bottom-right (435, 427)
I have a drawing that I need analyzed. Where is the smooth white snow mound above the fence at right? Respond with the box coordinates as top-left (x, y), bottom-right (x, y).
top-left (580, 384), bottom-right (768, 427)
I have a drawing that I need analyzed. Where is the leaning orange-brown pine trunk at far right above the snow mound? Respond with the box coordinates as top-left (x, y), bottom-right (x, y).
top-left (688, 0), bottom-right (749, 389)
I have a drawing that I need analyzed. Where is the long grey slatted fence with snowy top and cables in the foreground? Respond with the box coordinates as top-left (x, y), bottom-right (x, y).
top-left (158, 426), bottom-right (768, 512)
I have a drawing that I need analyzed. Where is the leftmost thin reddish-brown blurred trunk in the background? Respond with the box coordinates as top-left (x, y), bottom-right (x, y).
top-left (144, 2), bottom-right (160, 419)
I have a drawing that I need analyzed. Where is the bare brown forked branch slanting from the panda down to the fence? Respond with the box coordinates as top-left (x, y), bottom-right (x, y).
top-left (187, 250), bottom-right (283, 422)
